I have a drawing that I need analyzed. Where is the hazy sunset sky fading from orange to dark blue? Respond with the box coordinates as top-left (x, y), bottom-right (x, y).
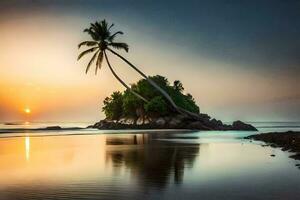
top-left (0, 0), bottom-right (300, 122)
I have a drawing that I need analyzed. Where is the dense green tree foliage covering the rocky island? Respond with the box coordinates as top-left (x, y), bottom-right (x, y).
top-left (103, 75), bottom-right (199, 119)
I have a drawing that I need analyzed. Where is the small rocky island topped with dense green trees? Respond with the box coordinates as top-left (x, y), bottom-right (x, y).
top-left (90, 75), bottom-right (257, 131)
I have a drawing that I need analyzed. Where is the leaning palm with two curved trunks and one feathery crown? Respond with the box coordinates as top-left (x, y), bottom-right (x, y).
top-left (78, 20), bottom-right (200, 119)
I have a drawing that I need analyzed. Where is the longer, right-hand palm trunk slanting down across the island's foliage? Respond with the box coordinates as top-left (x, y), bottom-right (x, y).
top-left (107, 48), bottom-right (201, 119)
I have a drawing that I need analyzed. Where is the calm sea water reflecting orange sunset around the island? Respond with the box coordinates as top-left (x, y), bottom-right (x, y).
top-left (0, 123), bottom-right (300, 200)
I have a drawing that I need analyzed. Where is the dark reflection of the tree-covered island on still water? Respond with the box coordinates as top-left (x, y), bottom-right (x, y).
top-left (106, 134), bottom-right (200, 188)
